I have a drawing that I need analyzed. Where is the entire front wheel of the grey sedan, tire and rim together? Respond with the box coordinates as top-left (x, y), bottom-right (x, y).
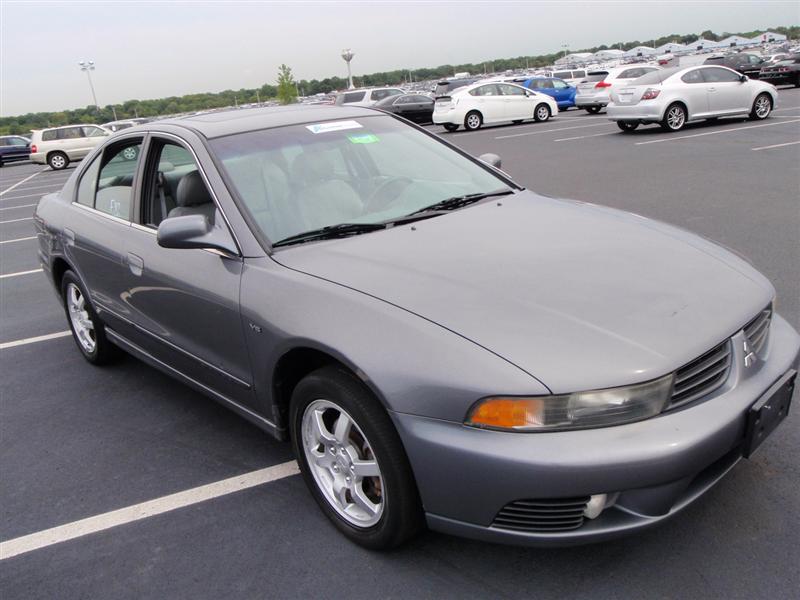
top-left (289, 367), bottom-right (423, 550)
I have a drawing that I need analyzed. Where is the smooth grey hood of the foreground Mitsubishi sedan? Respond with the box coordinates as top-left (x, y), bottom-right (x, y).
top-left (273, 191), bottom-right (774, 393)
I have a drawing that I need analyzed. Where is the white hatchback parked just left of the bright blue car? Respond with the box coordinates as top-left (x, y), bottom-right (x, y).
top-left (433, 83), bottom-right (558, 131)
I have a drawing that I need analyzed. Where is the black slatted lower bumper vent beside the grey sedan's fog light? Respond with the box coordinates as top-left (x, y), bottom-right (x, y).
top-left (492, 496), bottom-right (589, 533)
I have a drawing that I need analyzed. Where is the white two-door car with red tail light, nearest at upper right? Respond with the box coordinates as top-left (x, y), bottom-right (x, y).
top-left (608, 65), bottom-right (778, 132)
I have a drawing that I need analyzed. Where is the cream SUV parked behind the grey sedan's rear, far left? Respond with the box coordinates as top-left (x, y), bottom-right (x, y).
top-left (31, 125), bottom-right (111, 171)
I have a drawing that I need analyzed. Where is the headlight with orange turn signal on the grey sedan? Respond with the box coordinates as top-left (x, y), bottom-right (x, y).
top-left (464, 373), bottom-right (673, 431)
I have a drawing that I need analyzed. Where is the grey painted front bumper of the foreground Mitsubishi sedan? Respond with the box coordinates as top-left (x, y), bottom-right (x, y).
top-left (392, 315), bottom-right (800, 545)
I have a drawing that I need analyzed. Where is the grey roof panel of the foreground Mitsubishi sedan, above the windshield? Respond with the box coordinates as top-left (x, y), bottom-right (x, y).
top-left (148, 104), bottom-right (383, 138)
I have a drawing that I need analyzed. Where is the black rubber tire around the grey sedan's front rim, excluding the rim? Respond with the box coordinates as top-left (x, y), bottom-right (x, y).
top-left (289, 367), bottom-right (422, 550)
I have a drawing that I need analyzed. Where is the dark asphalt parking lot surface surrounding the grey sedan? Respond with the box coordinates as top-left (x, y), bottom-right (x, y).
top-left (0, 89), bottom-right (800, 599)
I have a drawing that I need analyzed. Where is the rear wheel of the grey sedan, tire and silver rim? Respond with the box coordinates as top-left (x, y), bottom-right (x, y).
top-left (61, 271), bottom-right (121, 365)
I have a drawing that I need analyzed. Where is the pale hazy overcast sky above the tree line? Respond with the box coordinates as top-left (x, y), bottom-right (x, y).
top-left (0, 0), bottom-right (800, 116)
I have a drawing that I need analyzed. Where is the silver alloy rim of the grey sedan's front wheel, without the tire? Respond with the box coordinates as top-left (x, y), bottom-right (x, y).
top-left (302, 399), bottom-right (386, 528)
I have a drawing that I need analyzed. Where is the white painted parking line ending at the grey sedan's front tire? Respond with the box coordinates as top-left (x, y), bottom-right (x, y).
top-left (0, 460), bottom-right (299, 560)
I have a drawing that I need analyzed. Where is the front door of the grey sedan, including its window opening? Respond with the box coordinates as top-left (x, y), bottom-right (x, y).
top-left (124, 136), bottom-right (253, 404)
